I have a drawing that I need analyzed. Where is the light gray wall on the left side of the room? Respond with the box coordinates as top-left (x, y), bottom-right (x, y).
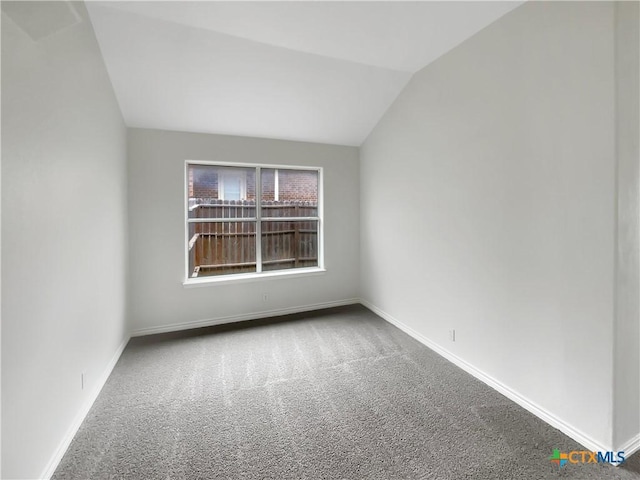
top-left (2, 2), bottom-right (128, 479)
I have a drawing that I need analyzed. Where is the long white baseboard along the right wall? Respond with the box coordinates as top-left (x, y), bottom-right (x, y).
top-left (360, 299), bottom-right (612, 453)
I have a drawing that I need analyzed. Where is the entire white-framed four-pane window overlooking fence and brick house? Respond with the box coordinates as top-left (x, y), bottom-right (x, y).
top-left (185, 161), bottom-right (322, 283)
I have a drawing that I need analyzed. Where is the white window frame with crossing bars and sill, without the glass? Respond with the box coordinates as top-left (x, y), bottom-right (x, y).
top-left (182, 160), bottom-right (326, 287)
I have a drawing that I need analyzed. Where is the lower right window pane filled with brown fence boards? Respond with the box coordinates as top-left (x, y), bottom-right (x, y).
top-left (262, 220), bottom-right (318, 271)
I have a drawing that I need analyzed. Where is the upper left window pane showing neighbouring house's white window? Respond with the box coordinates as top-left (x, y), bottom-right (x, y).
top-left (187, 165), bottom-right (256, 218)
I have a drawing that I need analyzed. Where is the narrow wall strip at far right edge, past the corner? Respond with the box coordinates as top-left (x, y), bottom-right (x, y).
top-left (613, 2), bottom-right (640, 449)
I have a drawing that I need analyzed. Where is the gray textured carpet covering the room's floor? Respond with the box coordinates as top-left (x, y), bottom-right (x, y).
top-left (53, 306), bottom-right (640, 480)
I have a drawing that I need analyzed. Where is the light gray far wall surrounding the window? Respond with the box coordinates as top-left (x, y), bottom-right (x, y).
top-left (128, 129), bottom-right (359, 334)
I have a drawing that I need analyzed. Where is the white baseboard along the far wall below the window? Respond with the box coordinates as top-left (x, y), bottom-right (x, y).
top-left (131, 298), bottom-right (360, 337)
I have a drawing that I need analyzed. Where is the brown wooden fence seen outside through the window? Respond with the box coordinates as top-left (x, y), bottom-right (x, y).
top-left (189, 199), bottom-right (318, 277)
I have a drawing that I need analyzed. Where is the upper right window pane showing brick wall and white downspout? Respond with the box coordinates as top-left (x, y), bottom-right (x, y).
top-left (261, 168), bottom-right (318, 217)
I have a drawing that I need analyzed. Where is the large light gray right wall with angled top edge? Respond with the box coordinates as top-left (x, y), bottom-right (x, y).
top-left (360, 2), bottom-right (616, 447)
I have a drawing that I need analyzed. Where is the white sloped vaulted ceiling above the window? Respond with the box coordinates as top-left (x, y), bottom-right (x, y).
top-left (87, 1), bottom-right (523, 145)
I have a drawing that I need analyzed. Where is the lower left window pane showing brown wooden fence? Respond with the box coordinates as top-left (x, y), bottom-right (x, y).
top-left (188, 222), bottom-right (256, 278)
